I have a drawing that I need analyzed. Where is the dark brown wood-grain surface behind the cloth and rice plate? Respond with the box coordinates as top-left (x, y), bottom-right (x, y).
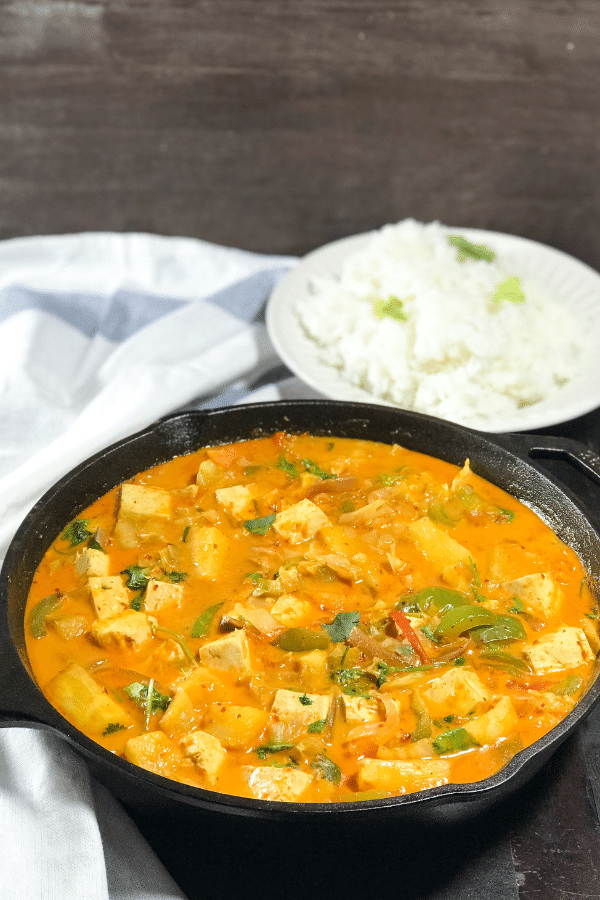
top-left (0, 0), bottom-right (600, 268)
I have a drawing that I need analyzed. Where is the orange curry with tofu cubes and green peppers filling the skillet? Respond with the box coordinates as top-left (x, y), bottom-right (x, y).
top-left (26, 433), bottom-right (600, 803)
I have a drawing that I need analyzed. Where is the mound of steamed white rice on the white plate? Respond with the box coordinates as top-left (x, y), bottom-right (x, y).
top-left (296, 219), bottom-right (582, 428)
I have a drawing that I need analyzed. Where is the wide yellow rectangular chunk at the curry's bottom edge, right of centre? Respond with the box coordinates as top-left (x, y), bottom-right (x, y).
top-left (358, 759), bottom-right (450, 794)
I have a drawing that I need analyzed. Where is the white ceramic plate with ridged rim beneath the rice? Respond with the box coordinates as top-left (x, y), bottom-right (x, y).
top-left (266, 227), bottom-right (600, 432)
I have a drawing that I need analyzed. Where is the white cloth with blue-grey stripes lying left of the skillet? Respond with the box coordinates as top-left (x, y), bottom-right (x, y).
top-left (0, 234), bottom-right (313, 900)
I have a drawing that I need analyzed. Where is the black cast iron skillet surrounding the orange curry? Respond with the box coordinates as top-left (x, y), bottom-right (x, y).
top-left (0, 400), bottom-right (600, 824)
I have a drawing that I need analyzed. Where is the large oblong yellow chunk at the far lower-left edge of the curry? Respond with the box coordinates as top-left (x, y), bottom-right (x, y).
top-left (47, 663), bottom-right (131, 734)
